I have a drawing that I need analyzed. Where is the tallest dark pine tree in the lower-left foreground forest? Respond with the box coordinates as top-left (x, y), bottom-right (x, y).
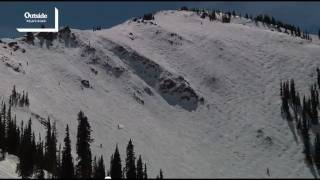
top-left (76, 111), bottom-right (92, 178)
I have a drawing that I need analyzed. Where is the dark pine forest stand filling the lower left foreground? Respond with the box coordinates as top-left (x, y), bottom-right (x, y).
top-left (0, 86), bottom-right (163, 179)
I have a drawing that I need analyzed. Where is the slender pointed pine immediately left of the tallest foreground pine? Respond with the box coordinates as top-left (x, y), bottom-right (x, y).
top-left (61, 125), bottom-right (74, 178)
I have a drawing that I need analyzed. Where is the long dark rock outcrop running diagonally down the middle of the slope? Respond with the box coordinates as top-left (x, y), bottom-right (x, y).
top-left (111, 41), bottom-right (200, 111)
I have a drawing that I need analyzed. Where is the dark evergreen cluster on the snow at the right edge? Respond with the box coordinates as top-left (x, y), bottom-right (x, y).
top-left (280, 68), bottom-right (320, 169)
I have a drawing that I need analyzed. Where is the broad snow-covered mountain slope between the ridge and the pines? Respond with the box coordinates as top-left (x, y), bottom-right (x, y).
top-left (0, 11), bottom-right (320, 178)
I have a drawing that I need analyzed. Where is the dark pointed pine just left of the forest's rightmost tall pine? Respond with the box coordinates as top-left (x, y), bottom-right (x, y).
top-left (110, 145), bottom-right (122, 179)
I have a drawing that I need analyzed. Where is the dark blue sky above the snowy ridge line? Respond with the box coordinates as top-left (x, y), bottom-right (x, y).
top-left (0, 1), bottom-right (320, 38)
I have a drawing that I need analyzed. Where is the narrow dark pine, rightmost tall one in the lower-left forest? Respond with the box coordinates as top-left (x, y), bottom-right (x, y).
top-left (126, 139), bottom-right (137, 179)
